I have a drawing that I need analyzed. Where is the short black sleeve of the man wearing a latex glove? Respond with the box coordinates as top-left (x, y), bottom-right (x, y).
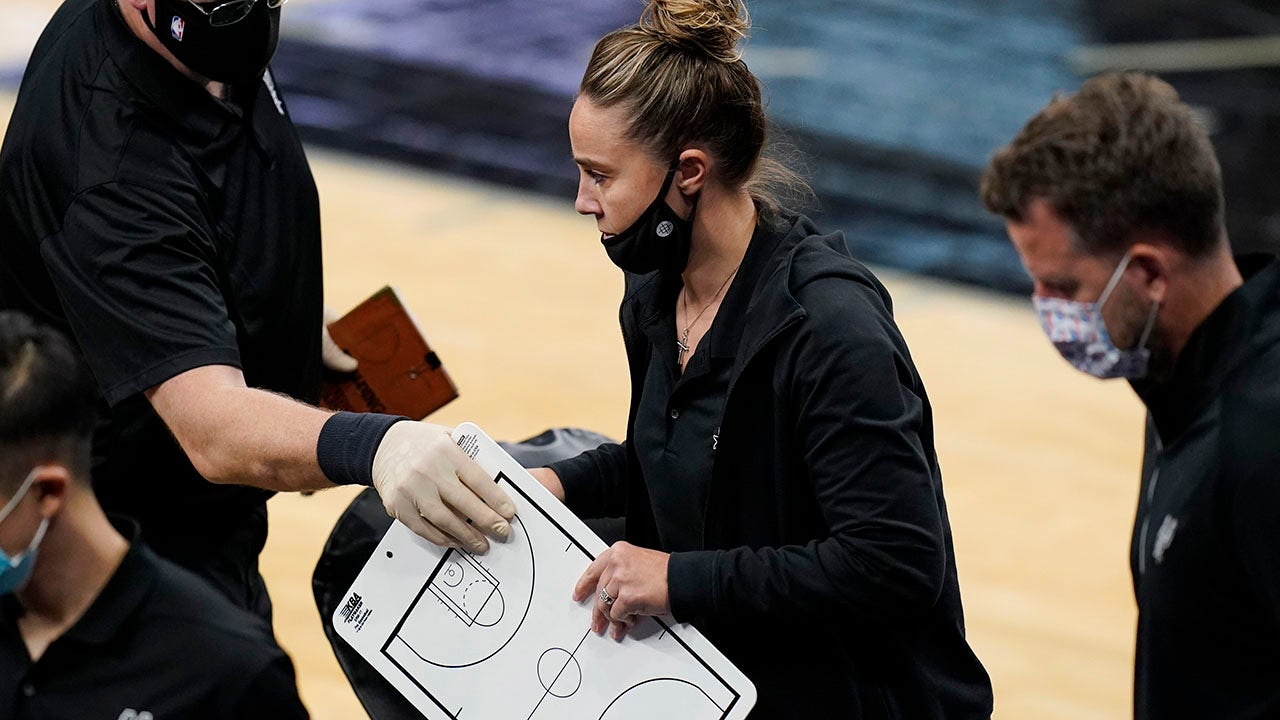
top-left (41, 182), bottom-right (239, 405)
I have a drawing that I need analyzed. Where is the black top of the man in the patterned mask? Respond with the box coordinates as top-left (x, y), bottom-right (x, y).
top-left (1130, 256), bottom-right (1280, 720)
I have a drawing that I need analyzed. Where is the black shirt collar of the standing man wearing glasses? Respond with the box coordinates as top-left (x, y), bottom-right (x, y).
top-left (96, 0), bottom-right (239, 145)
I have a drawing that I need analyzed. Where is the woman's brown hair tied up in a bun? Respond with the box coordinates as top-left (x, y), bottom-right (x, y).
top-left (579, 0), bottom-right (810, 215)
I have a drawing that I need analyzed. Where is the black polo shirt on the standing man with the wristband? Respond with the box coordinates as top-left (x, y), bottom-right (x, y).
top-left (0, 0), bottom-right (323, 603)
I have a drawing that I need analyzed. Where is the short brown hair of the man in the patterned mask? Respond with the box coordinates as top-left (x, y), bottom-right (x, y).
top-left (982, 73), bottom-right (1226, 258)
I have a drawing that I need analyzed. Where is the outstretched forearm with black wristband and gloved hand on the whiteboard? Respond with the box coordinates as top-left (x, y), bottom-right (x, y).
top-left (153, 365), bottom-right (516, 552)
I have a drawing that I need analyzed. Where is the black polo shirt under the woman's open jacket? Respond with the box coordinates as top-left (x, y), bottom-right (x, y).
top-left (635, 227), bottom-right (777, 552)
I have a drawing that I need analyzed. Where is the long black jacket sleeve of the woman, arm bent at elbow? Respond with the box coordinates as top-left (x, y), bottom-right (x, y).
top-left (668, 279), bottom-right (946, 624)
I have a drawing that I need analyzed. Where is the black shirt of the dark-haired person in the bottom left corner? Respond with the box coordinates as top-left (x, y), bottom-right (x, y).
top-left (0, 520), bottom-right (307, 720)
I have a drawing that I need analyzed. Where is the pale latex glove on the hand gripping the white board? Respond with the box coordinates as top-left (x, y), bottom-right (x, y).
top-left (372, 421), bottom-right (516, 553)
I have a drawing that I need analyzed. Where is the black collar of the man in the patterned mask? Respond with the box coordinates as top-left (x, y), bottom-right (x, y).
top-left (1133, 255), bottom-right (1280, 446)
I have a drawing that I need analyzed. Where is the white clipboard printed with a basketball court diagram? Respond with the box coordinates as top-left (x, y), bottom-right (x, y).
top-left (333, 423), bottom-right (756, 720)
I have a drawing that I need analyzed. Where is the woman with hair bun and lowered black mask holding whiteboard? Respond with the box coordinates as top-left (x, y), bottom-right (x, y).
top-left (524, 0), bottom-right (992, 719)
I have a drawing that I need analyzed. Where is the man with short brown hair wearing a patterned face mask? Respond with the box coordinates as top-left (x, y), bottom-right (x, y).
top-left (983, 74), bottom-right (1280, 720)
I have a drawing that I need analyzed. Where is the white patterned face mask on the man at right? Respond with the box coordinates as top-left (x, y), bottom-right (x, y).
top-left (1032, 252), bottom-right (1160, 379)
